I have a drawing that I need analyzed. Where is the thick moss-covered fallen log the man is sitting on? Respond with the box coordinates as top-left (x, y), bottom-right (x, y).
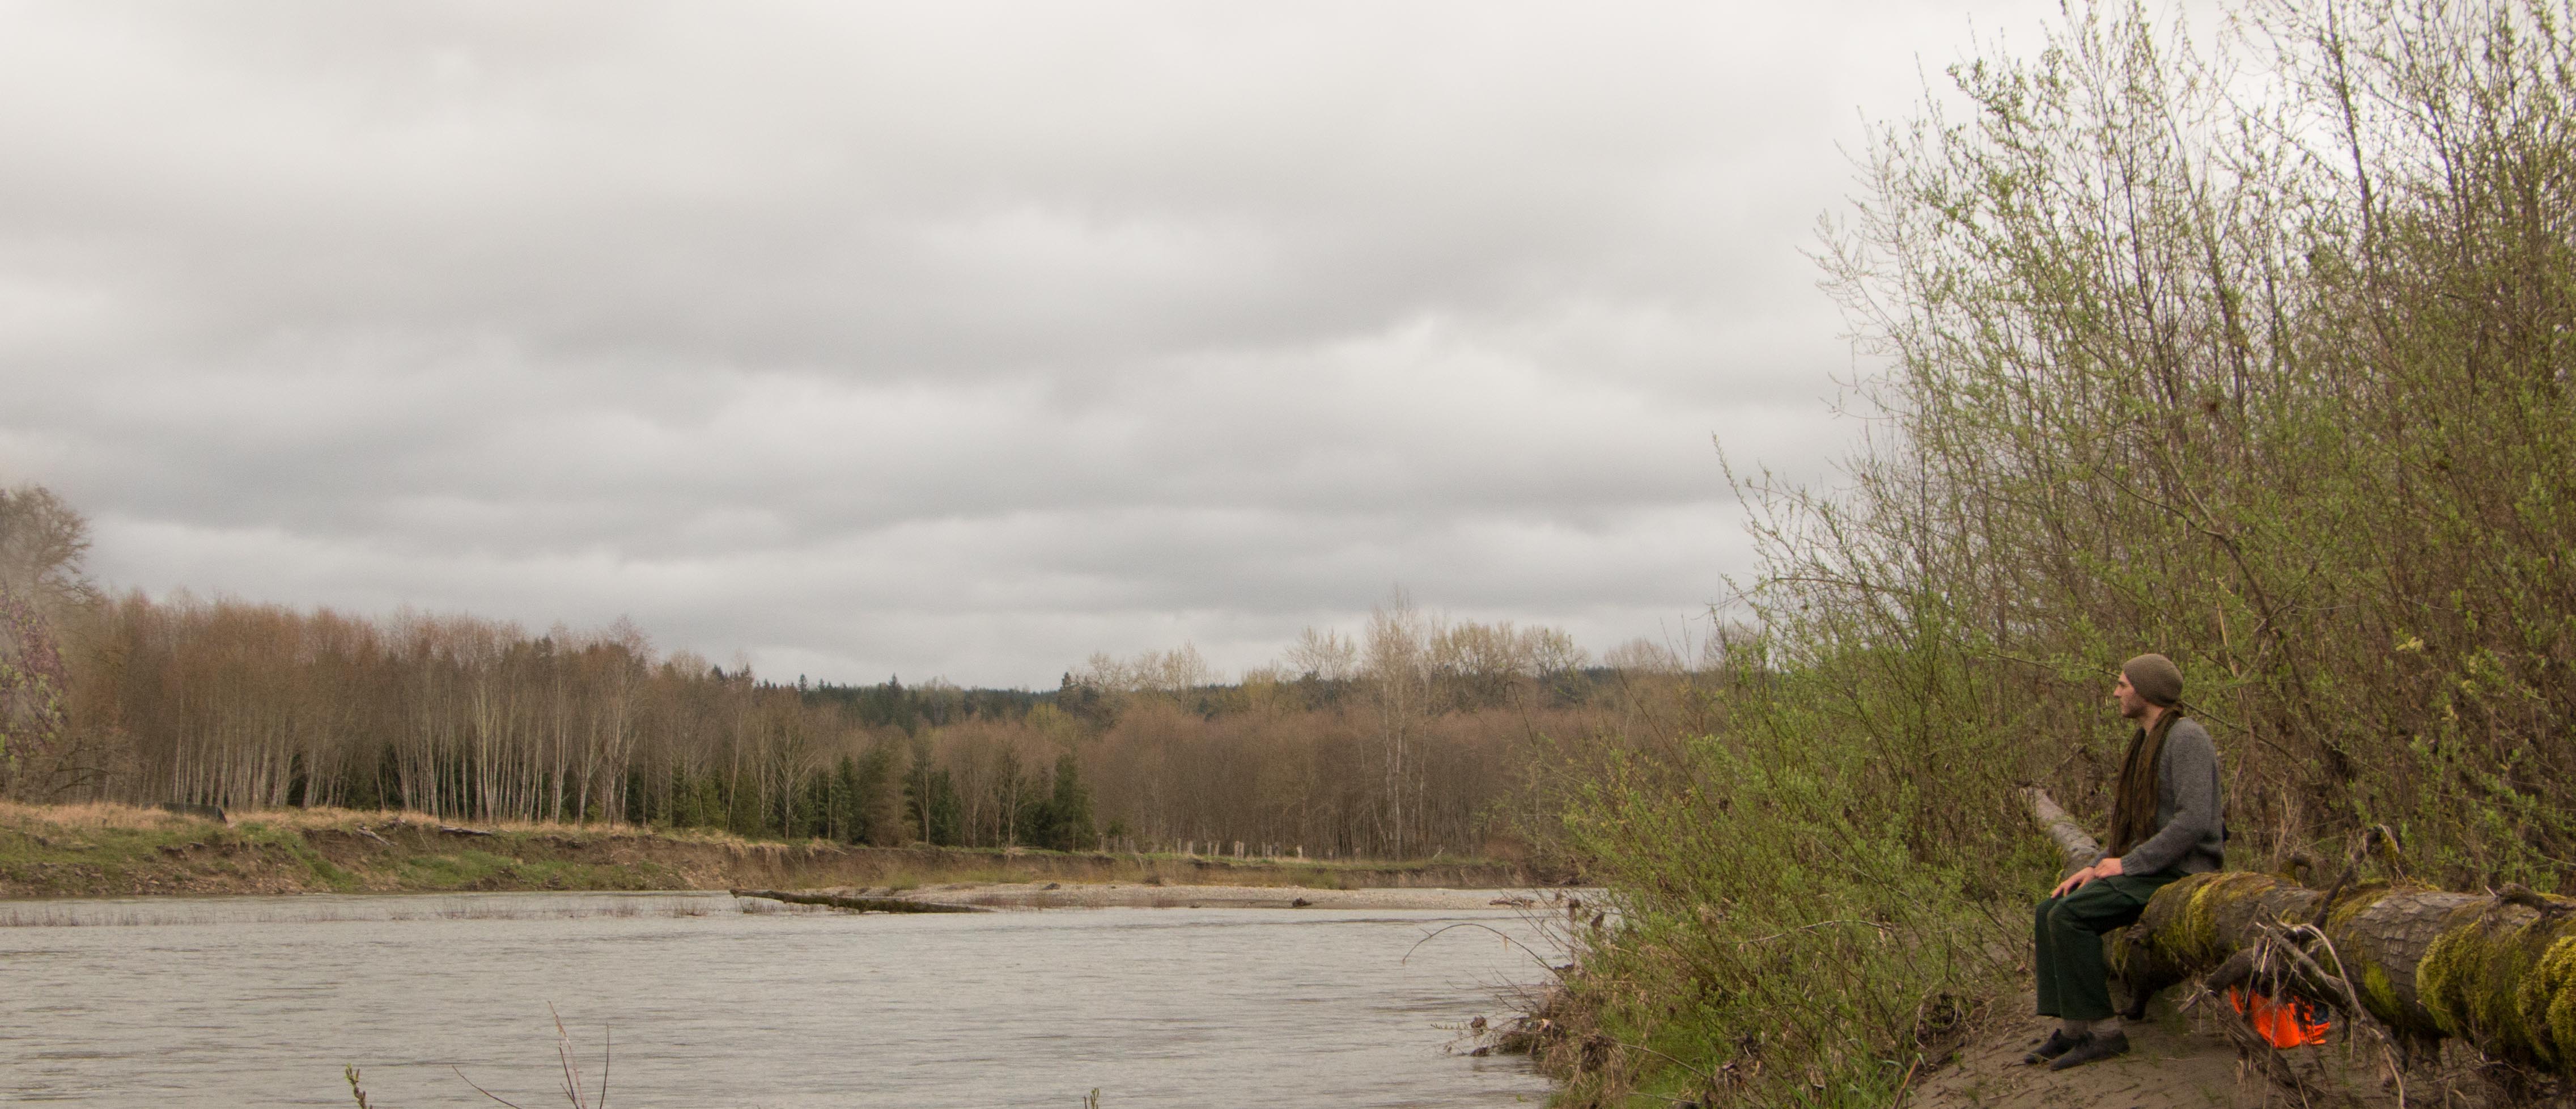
top-left (2027, 789), bottom-right (2576, 1076)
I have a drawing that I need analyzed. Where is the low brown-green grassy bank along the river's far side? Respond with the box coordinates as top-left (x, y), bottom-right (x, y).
top-left (0, 805), bottom-right (1520, 898)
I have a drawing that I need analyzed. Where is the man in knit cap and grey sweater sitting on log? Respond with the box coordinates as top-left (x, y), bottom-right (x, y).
top-left (2022, 655), bottom-right (2226, 1070)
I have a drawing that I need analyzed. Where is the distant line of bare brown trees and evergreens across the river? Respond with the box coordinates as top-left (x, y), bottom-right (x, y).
top-left (0, 488), bottom-right (1679, 856)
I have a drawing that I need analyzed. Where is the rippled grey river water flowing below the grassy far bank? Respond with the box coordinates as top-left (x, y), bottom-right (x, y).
top-left (0, 892), bottom-right (1548, 1109)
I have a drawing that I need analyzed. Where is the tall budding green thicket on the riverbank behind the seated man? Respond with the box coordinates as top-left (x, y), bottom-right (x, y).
top-left (1540, 0), bottom-right (2576, 1106)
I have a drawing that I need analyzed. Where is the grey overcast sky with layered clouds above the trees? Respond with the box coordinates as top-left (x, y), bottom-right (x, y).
top-left (0, 0), bottom-right (2053, 686)
